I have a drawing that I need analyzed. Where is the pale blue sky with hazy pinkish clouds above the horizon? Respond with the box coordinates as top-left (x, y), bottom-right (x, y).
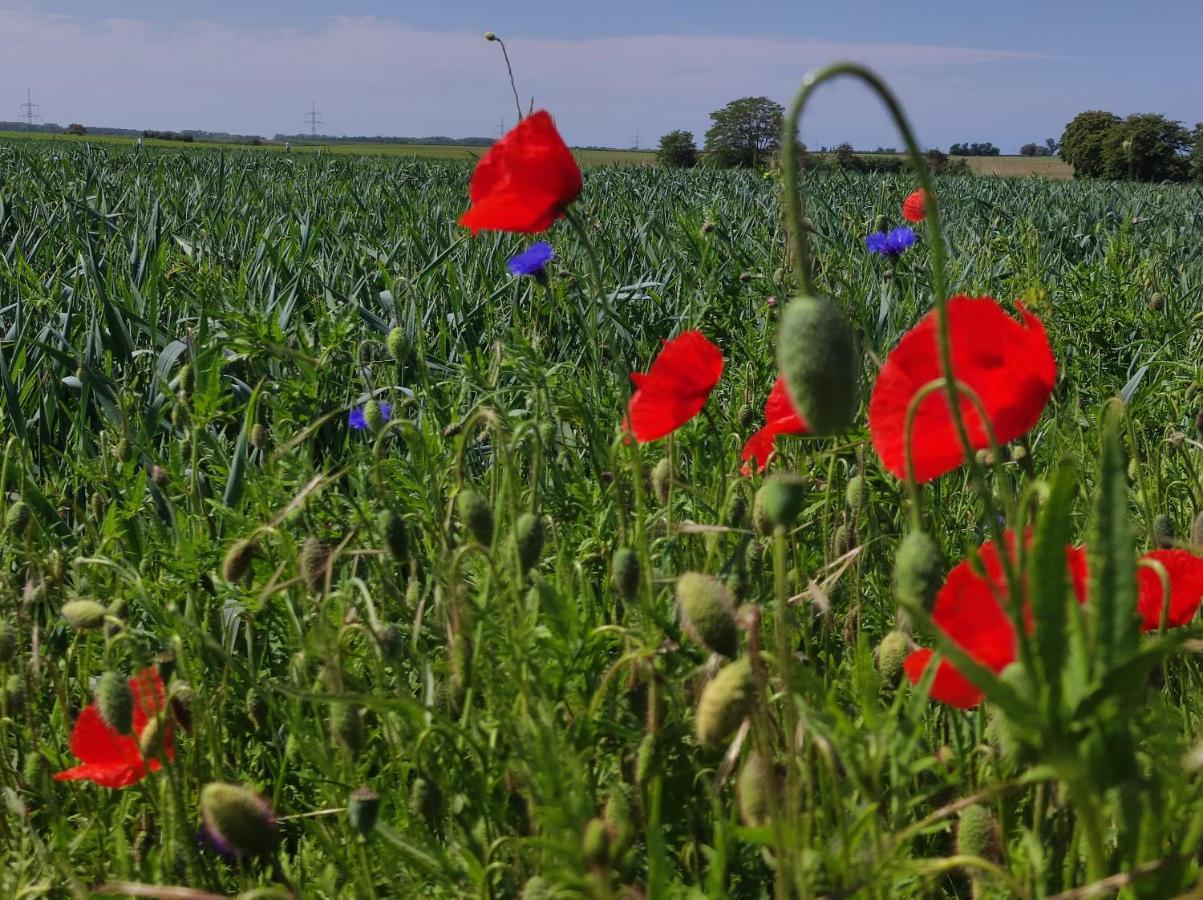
top-left (0, 0), bottom-right (1203, 152)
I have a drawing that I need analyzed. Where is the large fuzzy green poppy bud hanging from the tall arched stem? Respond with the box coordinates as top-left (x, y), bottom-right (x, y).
top-left (777, 296), bottom-right (860, 434)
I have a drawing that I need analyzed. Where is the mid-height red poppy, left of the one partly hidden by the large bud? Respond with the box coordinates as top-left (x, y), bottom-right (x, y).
top-left (626, 331), bottom-right (723, 444)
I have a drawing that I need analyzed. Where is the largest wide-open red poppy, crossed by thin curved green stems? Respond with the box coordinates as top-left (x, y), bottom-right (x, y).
top-left (869, 296), bottom-right (1056, 482)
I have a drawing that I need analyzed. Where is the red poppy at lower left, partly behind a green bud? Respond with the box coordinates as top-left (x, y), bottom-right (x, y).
top-left (54, 668), bottom-right (176, 788)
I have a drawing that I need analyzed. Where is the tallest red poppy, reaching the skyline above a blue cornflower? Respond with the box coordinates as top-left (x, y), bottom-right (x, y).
top-left (460, 109), bottom-right (581, 235)
